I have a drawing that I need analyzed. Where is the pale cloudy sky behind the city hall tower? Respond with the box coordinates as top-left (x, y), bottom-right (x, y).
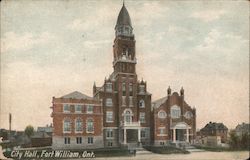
top-left (0, 0), bottom-right (249, 130)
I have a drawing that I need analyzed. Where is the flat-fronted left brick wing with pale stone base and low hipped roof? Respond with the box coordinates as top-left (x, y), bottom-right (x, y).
top-left (51, 91), bottom-right (103, 149)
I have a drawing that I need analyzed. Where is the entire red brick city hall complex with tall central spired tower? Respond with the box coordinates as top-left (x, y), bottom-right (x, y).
top-left (51, 4), bottom-right (196, 148)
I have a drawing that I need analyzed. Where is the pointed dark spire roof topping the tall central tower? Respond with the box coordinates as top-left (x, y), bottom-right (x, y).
top-left (116, 4), bottom-right (132, 27)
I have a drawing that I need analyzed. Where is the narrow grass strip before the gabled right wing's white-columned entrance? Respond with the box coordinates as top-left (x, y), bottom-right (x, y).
top-left (145, 146), bottom-right (189, 154)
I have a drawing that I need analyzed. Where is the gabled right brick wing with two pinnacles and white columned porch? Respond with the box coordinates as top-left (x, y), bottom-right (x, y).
top-left (152, 87), bottom-right (196, 145)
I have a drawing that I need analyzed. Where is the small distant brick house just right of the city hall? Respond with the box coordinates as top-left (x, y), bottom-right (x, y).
top-left (200, 122), bottom-right (228, 143)
